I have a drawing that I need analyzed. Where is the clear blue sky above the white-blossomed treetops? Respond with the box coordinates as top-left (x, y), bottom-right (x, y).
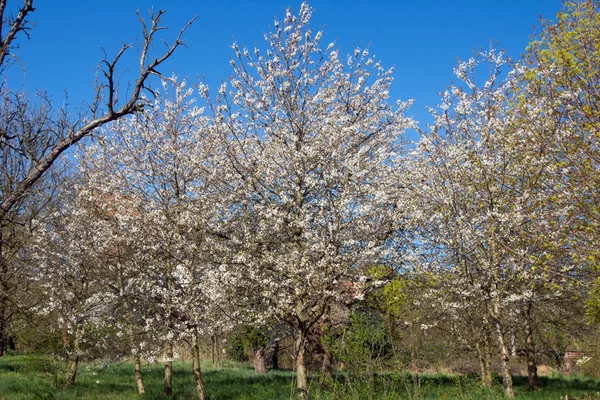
top-left (8, 0), bottom-right (561, 128)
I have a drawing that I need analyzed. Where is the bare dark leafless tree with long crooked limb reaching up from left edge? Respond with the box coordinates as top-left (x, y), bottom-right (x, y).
top-left (0, 0), bottom-right (195, 355)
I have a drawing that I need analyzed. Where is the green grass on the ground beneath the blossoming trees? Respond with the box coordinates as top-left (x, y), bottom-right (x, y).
top-left (0, 355), bottom-right (600, 400)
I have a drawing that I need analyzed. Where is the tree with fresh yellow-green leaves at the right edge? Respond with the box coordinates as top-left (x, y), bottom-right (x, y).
top-left (520, 0), bottom-right (600, 324)
